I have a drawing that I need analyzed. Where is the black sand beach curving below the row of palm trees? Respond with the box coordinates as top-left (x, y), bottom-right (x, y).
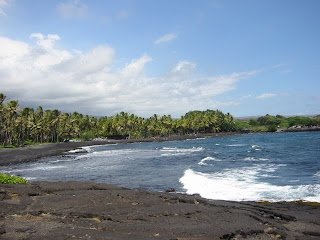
top-left (0, 132), bottom-right (238, 166)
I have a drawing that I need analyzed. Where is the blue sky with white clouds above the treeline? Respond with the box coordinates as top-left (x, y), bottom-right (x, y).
top-left (0, 0), bottom-right (320, 117)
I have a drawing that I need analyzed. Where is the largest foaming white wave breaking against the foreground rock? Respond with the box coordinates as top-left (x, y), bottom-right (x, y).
top-left (179, 167), bottom-right (320, 202)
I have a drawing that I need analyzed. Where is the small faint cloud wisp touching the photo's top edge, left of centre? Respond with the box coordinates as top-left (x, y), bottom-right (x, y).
top-left (57, 0), bottom-right (88, 18)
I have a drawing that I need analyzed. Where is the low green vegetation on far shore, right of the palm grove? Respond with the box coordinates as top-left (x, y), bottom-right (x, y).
top-left (235, 114), bottom-right (320, 132)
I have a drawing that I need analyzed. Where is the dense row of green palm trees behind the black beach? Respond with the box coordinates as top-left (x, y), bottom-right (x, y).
top-left (0, 93), bottom-right (235, 146)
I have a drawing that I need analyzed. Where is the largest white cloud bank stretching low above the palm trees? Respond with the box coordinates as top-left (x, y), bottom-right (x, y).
top-left (0, 33), bottom-right (257, 117)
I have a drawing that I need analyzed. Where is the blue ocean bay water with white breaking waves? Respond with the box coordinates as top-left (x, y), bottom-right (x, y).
top-left (0, 132), bottom-right (320, 202)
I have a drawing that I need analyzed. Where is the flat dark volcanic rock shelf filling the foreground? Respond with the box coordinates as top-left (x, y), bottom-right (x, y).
top-left (0, 182), bottom-right (320, 240)
